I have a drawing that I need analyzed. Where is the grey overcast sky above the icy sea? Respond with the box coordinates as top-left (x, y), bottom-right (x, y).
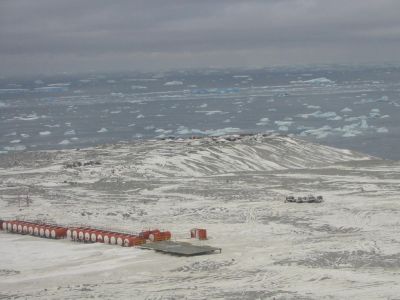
top-left (0, 0), bottom-right (400, 75)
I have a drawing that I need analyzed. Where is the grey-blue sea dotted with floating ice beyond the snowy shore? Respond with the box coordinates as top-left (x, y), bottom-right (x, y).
top-left (0, 66), bottom-right (400, 159)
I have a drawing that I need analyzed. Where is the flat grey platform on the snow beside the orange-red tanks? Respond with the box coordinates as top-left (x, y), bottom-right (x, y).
top-left (139, 241), bottom-right (222, 256)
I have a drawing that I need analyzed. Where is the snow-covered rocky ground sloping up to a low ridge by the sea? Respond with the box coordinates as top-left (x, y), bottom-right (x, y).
top-left (0, 135), bottom-right (400, 299)
